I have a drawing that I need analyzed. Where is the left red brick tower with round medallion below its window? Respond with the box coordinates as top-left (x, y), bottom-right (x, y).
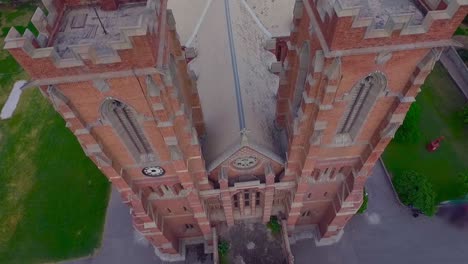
top-left (5, 0), bottom-right (212, 260)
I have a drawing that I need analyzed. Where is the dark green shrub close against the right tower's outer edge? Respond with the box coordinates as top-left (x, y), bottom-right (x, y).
top-left (394, 103), bottom-right (421, 143)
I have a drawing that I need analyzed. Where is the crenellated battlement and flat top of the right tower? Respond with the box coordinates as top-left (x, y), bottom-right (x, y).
top-left (313, 0), bottom-right (468, 38)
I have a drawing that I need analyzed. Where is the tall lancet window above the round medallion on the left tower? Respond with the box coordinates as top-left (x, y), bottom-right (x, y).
top-left (101, 99), bottom-right (155, 163)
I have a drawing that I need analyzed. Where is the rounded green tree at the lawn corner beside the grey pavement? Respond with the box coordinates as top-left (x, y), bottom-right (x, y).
top-left (393, 171), bottom-right (436, 216)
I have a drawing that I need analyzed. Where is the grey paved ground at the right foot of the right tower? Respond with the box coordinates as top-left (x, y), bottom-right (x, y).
top-left (291, 163), bottom-right (468, 264)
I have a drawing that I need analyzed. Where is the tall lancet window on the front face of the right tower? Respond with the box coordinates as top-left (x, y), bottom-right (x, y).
top-left (337, 72), bottom-right (387, 142)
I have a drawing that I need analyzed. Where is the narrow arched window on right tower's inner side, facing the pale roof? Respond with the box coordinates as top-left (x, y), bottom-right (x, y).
top-left (292, 42), bottom-right (310, 115)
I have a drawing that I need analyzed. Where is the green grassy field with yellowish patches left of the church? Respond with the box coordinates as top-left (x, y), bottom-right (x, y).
top-left (0, 3), bottom-right (110, 263)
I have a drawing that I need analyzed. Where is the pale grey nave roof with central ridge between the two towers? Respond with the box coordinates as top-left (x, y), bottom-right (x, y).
top-left (169, 0), bottom-right (294, 169)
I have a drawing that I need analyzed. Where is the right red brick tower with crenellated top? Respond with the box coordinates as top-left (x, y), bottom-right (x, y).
top-left (277, 0), bottom-right (468, 244)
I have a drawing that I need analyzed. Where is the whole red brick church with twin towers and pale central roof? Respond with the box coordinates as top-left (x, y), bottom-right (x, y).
top-left (5, 0), bottom-right (468, 260)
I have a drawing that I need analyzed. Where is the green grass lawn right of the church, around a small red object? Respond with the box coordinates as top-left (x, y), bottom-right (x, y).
top-left (383, 64), bottom-right (468, 202)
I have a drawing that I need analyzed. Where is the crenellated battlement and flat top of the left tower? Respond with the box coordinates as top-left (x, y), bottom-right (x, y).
top-left (5, 0), bottom-right (160, 68)
